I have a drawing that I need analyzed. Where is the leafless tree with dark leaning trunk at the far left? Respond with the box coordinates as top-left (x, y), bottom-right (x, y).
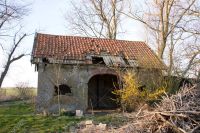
top-left (0, 0), bottom-right (28, 88)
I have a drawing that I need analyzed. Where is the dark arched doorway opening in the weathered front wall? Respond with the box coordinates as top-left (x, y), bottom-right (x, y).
top-left (88, 74), bottom-right (119, 109)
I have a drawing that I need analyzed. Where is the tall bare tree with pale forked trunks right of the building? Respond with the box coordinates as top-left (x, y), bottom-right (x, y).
top-left (123, 0), bottom-right (200, 74)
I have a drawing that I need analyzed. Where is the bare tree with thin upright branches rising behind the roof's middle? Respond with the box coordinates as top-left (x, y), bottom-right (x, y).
top-left (66, 0), bottom-right (126, 39)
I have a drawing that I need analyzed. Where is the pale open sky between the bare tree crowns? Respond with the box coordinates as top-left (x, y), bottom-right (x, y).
top-left (0, 0), bottom-right (145, 87)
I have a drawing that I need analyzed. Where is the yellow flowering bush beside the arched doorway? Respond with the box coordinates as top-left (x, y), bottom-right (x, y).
top-left (113, 72), bottom-right (166, 111)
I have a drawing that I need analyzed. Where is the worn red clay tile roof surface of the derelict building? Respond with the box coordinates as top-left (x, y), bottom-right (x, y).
top-left (32, 33), bottom-right (165, 68)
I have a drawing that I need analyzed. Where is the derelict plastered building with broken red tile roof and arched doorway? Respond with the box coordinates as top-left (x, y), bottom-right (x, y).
top-left (31, 33), bottom-right (165, 112)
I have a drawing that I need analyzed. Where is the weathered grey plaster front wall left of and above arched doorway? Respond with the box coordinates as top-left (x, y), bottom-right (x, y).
top-left (37, 64), bottom-right (116, 112)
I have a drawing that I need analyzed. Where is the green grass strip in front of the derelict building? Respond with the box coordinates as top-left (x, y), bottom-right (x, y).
top-left (0, 101), bottom-right (125, 133)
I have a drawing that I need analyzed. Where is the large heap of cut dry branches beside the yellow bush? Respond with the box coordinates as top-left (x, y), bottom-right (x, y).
top-left (116, 85), bottom-right (200, 133)
